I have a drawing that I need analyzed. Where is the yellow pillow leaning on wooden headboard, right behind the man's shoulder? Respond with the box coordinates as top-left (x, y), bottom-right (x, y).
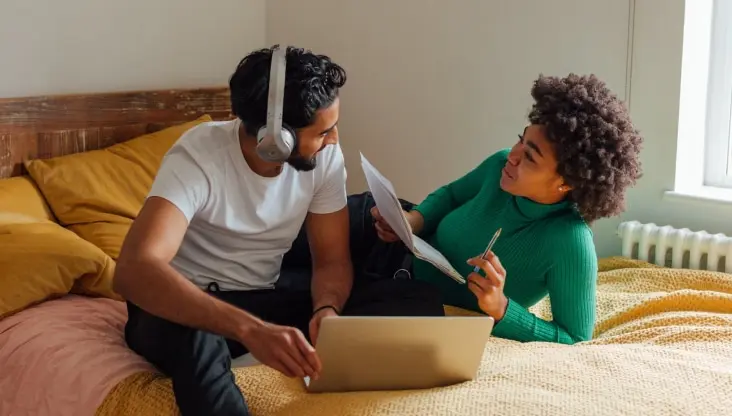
top-left (25, 115), bottom-right (212, 258)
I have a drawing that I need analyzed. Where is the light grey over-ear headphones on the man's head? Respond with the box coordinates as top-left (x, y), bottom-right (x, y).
top-left (257, 46), bottom-right (297, 162)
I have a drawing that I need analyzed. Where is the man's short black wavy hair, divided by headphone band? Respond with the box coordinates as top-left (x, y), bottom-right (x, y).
top-left (229, 45), bottom-right (346, 136)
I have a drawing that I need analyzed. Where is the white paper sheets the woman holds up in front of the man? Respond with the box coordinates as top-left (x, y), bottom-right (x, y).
top-left (361, 153), bottom-right (465, 284)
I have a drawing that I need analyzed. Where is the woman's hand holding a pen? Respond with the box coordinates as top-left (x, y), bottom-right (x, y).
top-left (468, 252), bottom-right (508, 322)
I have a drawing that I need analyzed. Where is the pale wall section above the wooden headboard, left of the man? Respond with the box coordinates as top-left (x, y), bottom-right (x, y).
top-left (0, 0), bottom-right (265, 97)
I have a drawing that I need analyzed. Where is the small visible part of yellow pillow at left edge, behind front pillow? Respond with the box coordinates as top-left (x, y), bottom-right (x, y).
top-left (0, 176), bottom-right (53, 220)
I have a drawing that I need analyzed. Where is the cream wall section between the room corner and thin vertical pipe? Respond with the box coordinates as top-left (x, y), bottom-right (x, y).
top-left (266, 0), bottom-right (632, 255)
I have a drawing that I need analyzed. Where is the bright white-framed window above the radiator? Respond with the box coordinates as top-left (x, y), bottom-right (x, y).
top-left (669, 0), bottom-right (732, 202)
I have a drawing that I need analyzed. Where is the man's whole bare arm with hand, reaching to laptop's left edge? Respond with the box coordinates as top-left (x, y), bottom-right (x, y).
top-left (114, 197), bottom-right (321, 378)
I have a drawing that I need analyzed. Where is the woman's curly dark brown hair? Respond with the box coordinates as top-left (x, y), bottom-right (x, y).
top-left (529, 74), bottom-right (643, 223)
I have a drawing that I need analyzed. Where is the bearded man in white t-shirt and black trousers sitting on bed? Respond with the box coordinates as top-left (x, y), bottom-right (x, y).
top-left (115, 48), bottom-right (443, 415)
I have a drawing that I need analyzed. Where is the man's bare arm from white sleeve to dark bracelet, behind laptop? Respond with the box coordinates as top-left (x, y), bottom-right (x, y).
top-left (306, 206), bottom-right (353, 312)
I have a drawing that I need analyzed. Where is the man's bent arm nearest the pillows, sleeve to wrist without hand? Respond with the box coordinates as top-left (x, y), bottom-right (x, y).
top-left (114, 197), bottom-right (263, 340)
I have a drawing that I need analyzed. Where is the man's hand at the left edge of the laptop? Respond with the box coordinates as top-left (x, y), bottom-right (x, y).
top-left (240, 322), bottom-right (322, 380)
